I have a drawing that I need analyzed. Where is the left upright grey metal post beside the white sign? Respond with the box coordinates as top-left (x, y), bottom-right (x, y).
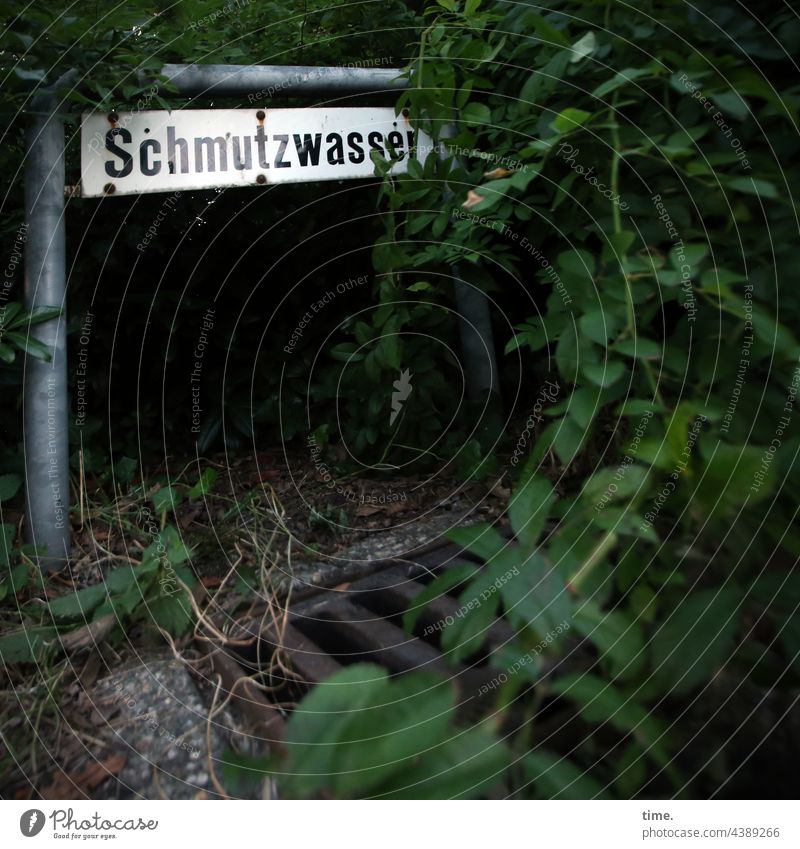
top-left (23, 93), bottom-right (70, 571)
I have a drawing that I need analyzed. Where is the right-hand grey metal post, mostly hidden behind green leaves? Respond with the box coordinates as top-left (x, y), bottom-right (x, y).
top-left (439, 124), bottom-right (500, 402)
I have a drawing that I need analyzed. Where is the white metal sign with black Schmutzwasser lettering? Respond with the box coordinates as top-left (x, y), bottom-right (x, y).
top-left (81, 107), bottom-right (432, 197)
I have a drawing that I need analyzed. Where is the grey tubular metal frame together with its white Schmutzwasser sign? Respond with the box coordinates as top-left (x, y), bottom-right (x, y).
top-left (23, 65), bottom-right (497, 570)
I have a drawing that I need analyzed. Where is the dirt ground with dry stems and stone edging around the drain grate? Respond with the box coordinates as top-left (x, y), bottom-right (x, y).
top-left (0, 440), bottom-right (510, 799)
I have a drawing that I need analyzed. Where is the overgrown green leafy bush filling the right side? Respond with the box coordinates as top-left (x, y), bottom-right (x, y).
top-left (340, 0), bottom-right (800, 796)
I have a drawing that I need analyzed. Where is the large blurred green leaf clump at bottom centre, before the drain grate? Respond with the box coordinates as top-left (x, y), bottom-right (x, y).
top-left (281, 664), bottom-right (508, 798)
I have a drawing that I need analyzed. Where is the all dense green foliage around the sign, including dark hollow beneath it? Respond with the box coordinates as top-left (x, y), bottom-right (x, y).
top-left (0, 0), bottom-right (800, 797)
